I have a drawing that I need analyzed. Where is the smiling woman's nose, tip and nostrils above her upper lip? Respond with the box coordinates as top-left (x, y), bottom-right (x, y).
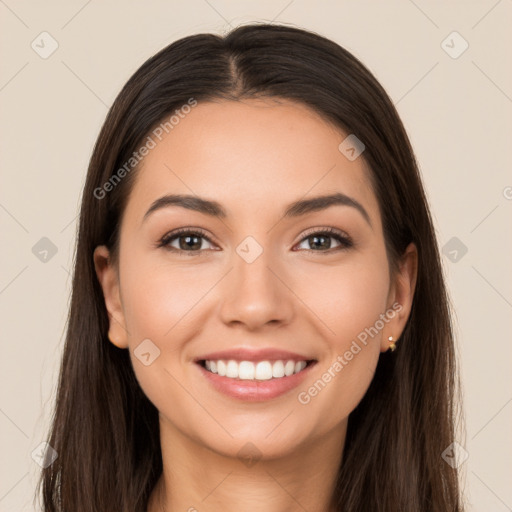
top-left (220, 245), bottom-right (294, 331)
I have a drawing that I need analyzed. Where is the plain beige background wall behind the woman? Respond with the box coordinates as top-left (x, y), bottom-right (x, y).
top-left (0, 0), bottom-right (512, 512)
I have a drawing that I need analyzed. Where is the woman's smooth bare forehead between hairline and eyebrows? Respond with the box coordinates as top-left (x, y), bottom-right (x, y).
top-left (126, 99), bottom-right (378, 222)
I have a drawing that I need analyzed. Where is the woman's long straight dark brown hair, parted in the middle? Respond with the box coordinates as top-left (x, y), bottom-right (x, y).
top-left (38, 24), bottom-right (463, 512)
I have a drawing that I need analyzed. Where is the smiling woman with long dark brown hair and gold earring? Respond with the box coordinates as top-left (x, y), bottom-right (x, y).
top-left (40, 24), bottom-right (463, 512)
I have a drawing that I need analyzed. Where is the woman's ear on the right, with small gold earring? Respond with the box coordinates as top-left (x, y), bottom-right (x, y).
top-left (381, 242), bottom-right (418, 352)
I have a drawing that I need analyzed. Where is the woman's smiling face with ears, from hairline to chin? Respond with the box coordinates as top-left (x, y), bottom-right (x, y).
top-left (95, 100), bottom-right (412, 458)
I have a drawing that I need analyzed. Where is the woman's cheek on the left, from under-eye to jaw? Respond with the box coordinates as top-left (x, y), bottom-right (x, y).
top-left (121, 253), bottom-right (211, 431)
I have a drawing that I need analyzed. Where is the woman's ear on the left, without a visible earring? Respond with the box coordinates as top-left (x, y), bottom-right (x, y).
top-left (93, 245), bottom-right (128, 348)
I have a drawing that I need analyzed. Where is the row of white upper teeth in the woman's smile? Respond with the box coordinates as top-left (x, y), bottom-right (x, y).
top-left (204, 359), bottom-right (307, 380)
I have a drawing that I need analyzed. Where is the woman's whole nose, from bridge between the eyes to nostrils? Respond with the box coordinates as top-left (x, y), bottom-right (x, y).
top-left (221, 236), bottom-right (292, 329)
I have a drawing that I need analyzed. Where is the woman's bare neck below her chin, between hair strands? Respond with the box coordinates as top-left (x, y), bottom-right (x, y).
top-left (148, 417), bottom-right (347, 512)
